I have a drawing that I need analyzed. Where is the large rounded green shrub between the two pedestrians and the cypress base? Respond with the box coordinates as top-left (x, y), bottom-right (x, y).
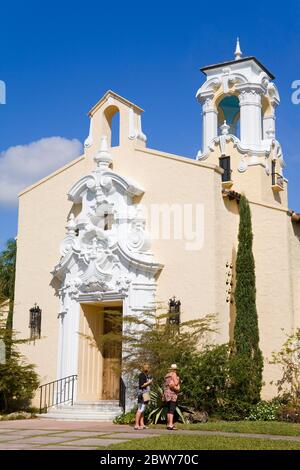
top-left (161, 344), bottom-right (262, 421)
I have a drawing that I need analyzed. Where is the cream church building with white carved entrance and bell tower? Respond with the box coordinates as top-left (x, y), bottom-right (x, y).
top-left (14, 43), bottom-right (300, 419)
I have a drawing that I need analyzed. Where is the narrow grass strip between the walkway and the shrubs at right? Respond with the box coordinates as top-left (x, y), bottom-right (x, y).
top-left (176, 421), bottom-right (300, 436)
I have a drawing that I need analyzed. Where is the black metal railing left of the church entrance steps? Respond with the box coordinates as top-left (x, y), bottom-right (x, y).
top-left (39, 375), bottom-right (77, 413)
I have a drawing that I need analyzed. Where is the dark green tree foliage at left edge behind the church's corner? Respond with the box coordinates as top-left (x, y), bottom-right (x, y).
top-left (0, 239), bottom-right (17, 330)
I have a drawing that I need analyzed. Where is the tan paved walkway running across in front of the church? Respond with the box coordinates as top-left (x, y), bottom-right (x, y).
top-left (0, 419), bottom-right (300, 450)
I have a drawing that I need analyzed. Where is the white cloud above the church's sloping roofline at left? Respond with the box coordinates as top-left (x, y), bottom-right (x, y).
top-left (0, 137), bottom-right (82, 205)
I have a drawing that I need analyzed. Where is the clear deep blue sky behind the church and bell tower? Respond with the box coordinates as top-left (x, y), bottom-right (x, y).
top-left (0, 0), bottom-right (300, 247)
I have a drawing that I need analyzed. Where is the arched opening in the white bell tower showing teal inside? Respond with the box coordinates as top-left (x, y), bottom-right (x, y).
top-left (217, 95), bottom-right (240, 138)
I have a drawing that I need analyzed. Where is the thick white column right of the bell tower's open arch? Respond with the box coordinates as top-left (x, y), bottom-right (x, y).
top-left (236, 85), bottom-right (262, 147)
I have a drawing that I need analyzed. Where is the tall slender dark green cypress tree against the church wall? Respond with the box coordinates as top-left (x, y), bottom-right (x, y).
top-left (232, 196), bottom-right (263, 404)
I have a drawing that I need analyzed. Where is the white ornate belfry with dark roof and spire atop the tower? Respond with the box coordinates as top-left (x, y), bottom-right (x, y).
top-left (196, 39), bottom-right (280, 159)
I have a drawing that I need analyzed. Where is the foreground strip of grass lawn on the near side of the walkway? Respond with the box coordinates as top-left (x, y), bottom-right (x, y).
top-left (99, 435), bottom-right (300, 450)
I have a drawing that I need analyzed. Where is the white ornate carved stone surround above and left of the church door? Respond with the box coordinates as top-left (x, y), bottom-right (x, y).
top-left (53, 137), bottom-right (162, 392)
